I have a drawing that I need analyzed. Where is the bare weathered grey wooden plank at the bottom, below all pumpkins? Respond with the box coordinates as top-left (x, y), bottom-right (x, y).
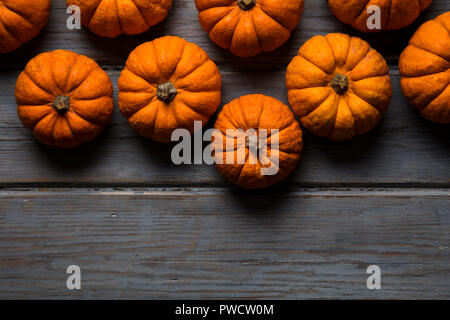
top-left (0, 189), bottom-right (450, 299)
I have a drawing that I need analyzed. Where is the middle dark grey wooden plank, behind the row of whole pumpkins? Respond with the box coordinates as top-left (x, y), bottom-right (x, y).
top-left (0, 70), bottom-right (450, 186)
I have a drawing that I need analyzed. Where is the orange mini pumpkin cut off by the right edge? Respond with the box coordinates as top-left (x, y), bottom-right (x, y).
top-left (399, 12), bottom-right (450, 123)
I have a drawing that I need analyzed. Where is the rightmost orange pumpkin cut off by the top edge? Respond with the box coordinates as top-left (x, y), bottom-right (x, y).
top-left (328, 0), bottom-right (432, 32)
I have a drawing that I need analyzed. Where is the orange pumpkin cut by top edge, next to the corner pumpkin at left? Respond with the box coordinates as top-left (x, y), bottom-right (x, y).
top-left (67, 0), bottom-right (172, 38)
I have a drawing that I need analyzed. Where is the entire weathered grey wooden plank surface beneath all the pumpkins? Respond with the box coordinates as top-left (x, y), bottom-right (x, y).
top-left (0, 0), bottom-right (450, 299)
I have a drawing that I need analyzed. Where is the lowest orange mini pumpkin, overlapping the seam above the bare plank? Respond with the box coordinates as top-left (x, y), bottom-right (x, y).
top-left (212, 94), bottom-right (303, 189)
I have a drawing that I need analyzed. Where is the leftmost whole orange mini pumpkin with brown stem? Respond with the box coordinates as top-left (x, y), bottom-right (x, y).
top-left (15, 50), bottom-right (113, 148)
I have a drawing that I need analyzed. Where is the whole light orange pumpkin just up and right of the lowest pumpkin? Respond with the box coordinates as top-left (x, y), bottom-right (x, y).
top-left (286, 33), bottom-right (392, 140)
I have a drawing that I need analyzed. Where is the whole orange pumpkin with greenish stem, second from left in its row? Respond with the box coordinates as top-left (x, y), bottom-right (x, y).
top-left (119, 36), bottom-right (222, 142)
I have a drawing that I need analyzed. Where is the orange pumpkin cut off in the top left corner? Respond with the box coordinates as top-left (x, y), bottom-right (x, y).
top-left (0, 0), bottom-right (51, 53)
